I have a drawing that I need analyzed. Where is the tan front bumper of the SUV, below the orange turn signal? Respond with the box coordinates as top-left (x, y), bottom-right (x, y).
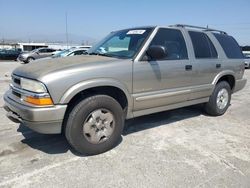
top-left (4, 91), bottom-right (67, 134)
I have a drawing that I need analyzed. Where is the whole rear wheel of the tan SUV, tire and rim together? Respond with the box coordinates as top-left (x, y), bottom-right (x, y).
top-left (205, 81), bottom-right (231, 116)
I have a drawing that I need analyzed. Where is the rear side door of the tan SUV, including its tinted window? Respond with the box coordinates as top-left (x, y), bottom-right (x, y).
top-left (188, 31), bottom-right (222, 100)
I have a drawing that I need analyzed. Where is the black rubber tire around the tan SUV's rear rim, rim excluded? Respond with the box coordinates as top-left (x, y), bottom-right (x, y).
top-left (205, 81), bottom-right (232, 116)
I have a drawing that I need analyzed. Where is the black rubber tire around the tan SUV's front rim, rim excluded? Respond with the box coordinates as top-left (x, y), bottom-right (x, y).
top-left (65, 95), bottom-right (124, 155)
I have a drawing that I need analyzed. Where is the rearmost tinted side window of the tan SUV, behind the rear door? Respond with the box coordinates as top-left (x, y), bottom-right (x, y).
top-left (214, 33), bottom-right (243, 59)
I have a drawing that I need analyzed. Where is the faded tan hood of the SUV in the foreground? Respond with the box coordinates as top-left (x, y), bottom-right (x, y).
top-left (13, 55), bottom-right (118, 80)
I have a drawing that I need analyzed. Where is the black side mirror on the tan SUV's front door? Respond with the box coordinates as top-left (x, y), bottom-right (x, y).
top-left (146, 45), bottom-right (167, 60)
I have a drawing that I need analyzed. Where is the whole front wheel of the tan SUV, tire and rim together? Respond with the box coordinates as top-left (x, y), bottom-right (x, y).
top-left (65, 95), bottom-right (124, 155)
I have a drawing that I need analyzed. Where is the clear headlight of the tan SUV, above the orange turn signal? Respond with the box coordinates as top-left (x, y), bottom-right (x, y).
top-left (20, 78), bottom-right (47, 93)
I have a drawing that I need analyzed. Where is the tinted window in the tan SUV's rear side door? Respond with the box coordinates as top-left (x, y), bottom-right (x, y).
top-left (188, 31), bottom-right (218, 58)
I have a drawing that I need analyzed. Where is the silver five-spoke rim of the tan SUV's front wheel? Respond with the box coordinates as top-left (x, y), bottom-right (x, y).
top-left (83, 109), bottom-right (115, 144)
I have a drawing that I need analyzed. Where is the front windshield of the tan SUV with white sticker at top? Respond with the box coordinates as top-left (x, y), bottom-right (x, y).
top-left (88, 28), bottom-right (153, 58)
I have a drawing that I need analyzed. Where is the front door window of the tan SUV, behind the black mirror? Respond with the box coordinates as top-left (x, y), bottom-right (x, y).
top-left (150, 28), bottom-right (188, 60)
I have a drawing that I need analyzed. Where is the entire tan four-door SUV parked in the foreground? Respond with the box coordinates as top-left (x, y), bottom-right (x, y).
top-left (4, 25), bottom-right (246, 154)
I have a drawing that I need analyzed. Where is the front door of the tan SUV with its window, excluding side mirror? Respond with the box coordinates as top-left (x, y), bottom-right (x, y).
top-left (133, 28), bottom-right (192, 111)
